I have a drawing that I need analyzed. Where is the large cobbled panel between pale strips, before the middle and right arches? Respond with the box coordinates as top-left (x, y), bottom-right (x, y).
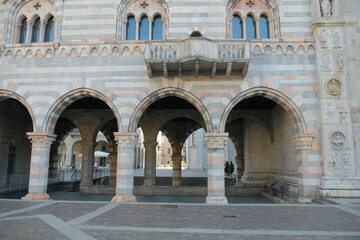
top-left (85, 204), bottom-right (360, 231)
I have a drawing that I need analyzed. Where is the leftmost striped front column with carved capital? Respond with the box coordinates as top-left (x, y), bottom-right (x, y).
top-left (22, 133), bottom-right (56, 200)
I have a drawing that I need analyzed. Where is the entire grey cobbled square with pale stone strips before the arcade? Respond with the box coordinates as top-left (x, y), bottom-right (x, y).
top-left (0, 199), bottom-right (360, 240)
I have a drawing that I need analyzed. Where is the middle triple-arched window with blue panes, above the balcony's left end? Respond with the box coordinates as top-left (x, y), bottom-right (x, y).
top-left (117, 0), bottom-right (168, 40)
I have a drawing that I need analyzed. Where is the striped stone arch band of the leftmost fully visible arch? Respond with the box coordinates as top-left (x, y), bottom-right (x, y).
top-left (42, 88), bottom-right (122, 134)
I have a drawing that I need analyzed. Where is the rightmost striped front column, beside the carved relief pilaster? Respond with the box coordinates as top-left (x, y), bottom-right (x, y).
top-left (293, 134), bottom-right (318, 203)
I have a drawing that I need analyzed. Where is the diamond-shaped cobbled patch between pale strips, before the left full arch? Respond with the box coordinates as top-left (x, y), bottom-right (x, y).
top-left (12, 202), bottom-right (106, 221)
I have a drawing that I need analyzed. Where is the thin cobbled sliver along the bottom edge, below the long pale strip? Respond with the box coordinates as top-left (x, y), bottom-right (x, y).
top-left (85, 230), bottom-right (359, 240)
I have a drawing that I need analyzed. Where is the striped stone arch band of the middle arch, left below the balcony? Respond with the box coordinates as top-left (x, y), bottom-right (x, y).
top-left (129, 87), bottom-right (213, 132)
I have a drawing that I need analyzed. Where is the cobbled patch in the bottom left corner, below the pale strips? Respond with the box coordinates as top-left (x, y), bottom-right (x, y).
top-left (0, 218), bottom-right (69, 240)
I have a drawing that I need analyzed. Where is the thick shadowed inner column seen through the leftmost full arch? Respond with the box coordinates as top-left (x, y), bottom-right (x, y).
top-left (80, 140), bottom-right (94, 189)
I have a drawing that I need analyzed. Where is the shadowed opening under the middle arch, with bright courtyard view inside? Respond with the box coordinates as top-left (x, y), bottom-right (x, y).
top-left (135, 96), bottom-right (207, 195)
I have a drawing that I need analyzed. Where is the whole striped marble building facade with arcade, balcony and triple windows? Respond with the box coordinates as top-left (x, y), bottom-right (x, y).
top-left (0, 0), bottom-right (360, 203)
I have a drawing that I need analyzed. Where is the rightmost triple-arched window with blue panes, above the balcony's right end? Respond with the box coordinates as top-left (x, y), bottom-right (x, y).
top-left (227, 0), bottom-right (280, 39)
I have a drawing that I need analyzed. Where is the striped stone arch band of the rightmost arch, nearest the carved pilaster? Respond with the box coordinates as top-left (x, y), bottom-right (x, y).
top-left (219, 87), bottom-right (307, 133)
